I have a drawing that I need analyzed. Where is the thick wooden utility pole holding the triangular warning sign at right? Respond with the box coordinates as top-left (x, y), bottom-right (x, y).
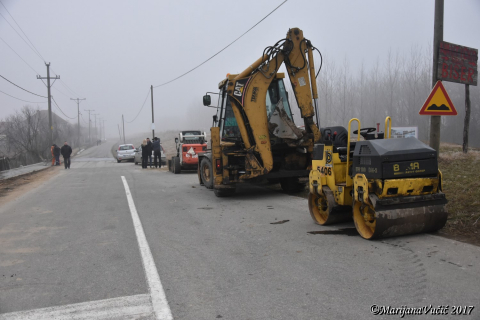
top-left (430, 0), bottom-right (444, 154)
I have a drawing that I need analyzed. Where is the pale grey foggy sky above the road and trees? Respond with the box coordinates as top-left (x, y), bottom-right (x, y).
top-left (0, 0), bottom-right (480, 137)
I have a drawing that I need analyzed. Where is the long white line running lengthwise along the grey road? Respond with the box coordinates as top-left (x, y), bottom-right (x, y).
top-left (122, 176), bottom-right (173, 320)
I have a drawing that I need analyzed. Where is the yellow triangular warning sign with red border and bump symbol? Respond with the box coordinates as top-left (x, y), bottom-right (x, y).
top-left (419, 81), bottom-right (457, 116)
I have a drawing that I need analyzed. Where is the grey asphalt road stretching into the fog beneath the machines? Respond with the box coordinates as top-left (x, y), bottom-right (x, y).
top-left (0, 143), bottom-right (480, 319)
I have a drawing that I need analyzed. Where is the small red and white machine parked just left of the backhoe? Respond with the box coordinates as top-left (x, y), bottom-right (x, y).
top-left (168, 130), bottom-right (207, 173)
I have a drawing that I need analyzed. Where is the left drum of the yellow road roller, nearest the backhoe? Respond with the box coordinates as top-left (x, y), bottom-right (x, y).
top-left (308, 186), bottom-right (352, 226)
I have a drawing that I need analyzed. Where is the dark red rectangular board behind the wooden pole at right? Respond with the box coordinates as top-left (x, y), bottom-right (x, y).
top-left (437, 41), bottom-right (478, 86)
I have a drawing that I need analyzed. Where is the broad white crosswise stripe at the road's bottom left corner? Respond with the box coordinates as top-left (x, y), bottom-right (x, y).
top-left (0, 294), bottom-right (154, 320)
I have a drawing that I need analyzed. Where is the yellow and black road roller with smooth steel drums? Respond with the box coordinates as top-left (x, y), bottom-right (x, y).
top-left (308, 117), bottom-right (447, 239)
